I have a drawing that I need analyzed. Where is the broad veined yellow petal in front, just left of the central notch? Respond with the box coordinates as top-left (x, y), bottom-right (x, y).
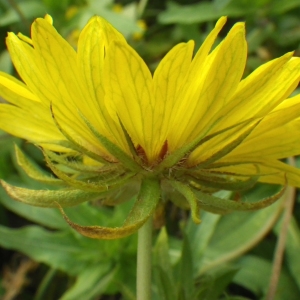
top-left (104, 42), bottom-right (160, 162)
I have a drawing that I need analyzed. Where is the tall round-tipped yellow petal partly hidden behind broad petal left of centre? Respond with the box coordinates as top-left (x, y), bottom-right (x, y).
top-left (77, 16), bottom-right (128, 156)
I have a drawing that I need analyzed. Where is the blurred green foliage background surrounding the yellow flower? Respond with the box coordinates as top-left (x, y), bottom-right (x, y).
top-left (0, 0), bottom-right (300, 300)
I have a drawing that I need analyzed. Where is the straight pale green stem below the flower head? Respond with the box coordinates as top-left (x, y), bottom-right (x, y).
top-left (136, 217), bottom-right (152, 300)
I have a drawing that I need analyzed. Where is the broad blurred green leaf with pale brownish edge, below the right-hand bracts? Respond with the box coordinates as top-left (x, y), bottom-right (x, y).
top-left (188, 185), bottom-right (282, 275)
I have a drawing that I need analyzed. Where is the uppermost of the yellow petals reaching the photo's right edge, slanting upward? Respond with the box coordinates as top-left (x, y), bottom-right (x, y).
top-left (215, 53), bottom-right (300, 130)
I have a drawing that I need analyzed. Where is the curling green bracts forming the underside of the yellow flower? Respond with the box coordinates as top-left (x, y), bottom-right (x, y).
top-left (2, 116), bottom-right (285, 239)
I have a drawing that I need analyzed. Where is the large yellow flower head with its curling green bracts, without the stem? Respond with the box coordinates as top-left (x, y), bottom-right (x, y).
top-left (0, 16), bottom-right (300, 238)
